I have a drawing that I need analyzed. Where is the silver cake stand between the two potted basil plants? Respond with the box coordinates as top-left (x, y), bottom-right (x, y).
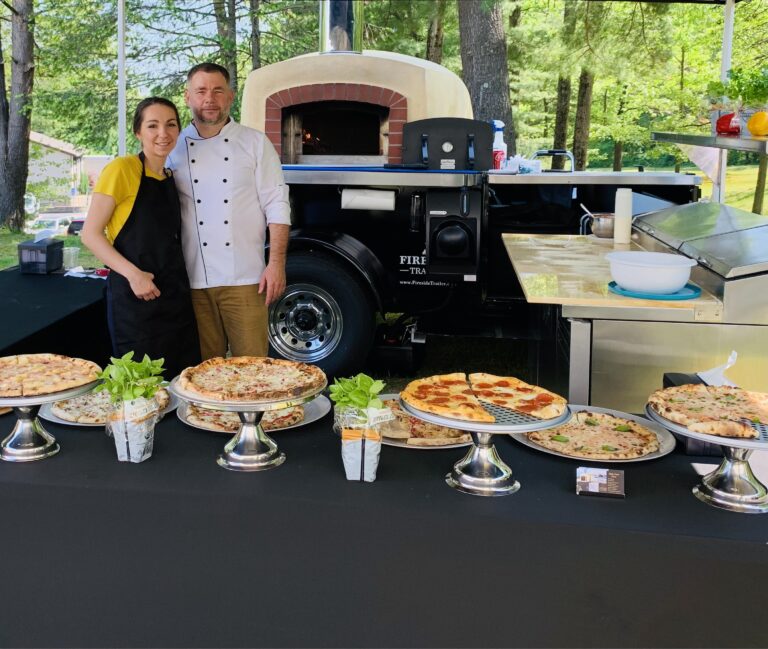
top-left (168, 377), bottom-right (326, 471)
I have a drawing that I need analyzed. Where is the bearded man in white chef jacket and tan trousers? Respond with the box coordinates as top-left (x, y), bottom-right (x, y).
top-left (168, 63), bottom-right (291, 359)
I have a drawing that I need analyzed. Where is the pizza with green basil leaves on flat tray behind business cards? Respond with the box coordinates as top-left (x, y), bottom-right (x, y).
top-left (528, 410), bottom-right (659, 460)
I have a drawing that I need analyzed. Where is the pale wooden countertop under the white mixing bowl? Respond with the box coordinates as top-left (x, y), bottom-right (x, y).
top-left (501, 234), bottom-right (723, 322)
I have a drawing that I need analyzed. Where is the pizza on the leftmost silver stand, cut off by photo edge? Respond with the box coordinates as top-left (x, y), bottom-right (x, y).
top-left (0, 354), bottom-right (101, 397)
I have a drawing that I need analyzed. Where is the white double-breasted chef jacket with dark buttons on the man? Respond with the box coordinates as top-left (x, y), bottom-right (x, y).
top-left (166, 120), bottom-right (291, 288)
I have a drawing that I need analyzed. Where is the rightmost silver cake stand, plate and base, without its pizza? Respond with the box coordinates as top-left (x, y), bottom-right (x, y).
top-left (645, 405), bottom-right (768, 514)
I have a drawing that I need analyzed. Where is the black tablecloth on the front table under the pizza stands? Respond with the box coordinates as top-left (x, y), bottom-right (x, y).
top-left (0, 408), bottom-right (768, 647)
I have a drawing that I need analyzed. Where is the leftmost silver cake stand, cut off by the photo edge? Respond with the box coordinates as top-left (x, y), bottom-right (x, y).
top-left (0, 380), bottom-right (98, 462)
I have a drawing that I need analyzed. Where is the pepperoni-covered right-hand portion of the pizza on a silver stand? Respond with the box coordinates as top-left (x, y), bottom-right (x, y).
top-left (469, 373), bottom-right (567, 419)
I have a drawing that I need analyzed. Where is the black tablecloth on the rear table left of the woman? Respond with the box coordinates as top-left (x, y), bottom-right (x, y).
top-left (0, 267), bottom-right (110, 364)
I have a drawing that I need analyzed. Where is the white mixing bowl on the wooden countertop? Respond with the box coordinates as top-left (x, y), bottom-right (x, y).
top-left (605, 251), bottom-right (696, 295)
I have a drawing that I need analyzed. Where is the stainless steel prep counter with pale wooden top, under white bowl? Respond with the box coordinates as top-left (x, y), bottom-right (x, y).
top-left (502, 230), bottom-right (768, 412)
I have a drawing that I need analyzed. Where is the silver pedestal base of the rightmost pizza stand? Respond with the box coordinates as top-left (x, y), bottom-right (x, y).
top-left (693, 446), bottom-right (768, 514)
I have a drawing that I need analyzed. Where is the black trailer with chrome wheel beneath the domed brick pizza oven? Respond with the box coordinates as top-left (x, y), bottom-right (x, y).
top-left (270, 165), bottom-right (700, 374)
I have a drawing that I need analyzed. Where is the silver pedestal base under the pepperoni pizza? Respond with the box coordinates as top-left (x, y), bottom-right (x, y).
top-left (445, 433), bottom-right (520, 496)
